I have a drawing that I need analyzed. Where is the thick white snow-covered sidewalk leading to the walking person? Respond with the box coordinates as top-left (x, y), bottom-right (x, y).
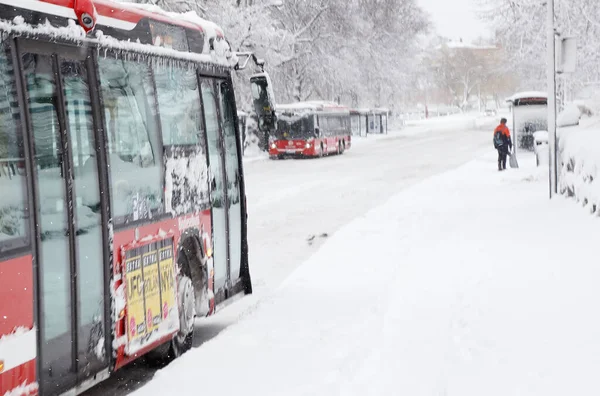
top-left (134, 150), bottom-right (600, 396)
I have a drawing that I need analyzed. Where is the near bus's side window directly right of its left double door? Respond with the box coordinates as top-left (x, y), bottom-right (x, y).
top-left (98, 58), bottom-right (163, 224)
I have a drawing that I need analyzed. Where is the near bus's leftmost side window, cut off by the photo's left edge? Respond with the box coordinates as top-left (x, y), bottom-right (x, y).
top-left (0, 42), bottom-right (29, 253)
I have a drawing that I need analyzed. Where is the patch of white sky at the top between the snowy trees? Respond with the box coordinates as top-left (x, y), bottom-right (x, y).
top-left (418, 0), bottom-right (490, 42)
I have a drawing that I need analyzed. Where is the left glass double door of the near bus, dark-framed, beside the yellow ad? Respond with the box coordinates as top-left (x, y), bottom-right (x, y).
top-left (17, 39), bottom-right (110, 394)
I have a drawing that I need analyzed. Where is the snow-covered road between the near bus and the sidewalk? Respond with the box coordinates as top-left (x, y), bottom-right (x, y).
top-left (86, 121), bottom-right (493, 396)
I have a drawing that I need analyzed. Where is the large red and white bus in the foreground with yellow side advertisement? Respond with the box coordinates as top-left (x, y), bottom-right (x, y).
top-left (0, 0), bottom-right (260, 396)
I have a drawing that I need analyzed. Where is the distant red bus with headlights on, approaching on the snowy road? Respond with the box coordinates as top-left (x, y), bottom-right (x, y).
top-left (269, 101), bottom-right (352, 159)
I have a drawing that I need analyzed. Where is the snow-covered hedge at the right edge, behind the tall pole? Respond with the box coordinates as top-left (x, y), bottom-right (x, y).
top-left (558, 118), bottom-right (600, 216)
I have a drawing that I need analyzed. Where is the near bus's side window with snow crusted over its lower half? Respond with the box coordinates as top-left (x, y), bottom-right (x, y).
top-left (153, 60), bottom-right (210, 215)
